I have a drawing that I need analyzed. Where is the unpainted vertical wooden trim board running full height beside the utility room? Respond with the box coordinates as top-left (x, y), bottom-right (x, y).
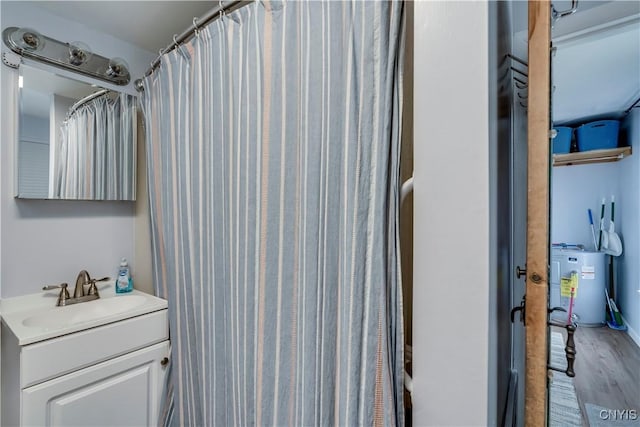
top-left (525, 0), bottom-right (551, 427)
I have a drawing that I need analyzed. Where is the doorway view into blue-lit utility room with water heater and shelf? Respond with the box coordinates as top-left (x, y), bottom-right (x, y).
top-left (549, 2), bottom-right (640, 425)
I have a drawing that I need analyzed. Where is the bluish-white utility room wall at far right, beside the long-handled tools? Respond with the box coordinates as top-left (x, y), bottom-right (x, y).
top-left (616, 108), bottom-right (640, 346)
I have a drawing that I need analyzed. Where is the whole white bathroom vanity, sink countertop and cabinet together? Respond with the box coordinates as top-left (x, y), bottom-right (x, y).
top-left (0, 282), bottom-right (170, 426)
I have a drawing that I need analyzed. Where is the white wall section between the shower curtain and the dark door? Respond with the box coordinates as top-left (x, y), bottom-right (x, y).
top-left (413, 1), bottom-right (491, 426)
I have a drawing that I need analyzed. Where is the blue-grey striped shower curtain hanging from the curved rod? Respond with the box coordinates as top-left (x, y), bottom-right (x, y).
top-left (142, 1), bottom-right (404, 426)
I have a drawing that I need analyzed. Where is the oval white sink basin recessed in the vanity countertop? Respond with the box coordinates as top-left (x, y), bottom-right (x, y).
top-left (22, 295), bottom-right (147, 329)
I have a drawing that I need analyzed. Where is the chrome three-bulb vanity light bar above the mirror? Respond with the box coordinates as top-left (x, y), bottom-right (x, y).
top-left (2, 27), bottom-right (131, 86)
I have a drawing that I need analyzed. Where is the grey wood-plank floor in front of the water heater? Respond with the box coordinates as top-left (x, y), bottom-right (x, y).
top-left (553, 327), bottom-right (640, 414)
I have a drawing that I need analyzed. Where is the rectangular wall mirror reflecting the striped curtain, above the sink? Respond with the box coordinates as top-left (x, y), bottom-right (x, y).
top-left (15, 64), bottom-right (137, 200)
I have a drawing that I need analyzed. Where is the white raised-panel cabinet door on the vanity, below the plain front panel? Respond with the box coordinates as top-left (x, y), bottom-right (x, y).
top-left (21, 341), bottom-right (169, 426)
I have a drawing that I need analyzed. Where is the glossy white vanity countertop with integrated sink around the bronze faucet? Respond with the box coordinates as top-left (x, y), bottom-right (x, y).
top-left (0, 282), bottom-right (168, 345)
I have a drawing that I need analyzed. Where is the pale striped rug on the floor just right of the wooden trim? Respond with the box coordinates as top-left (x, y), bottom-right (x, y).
top-left (549, 332), bottom-right (582, 427)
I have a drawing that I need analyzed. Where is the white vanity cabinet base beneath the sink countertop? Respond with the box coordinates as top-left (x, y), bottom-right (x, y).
top-left (0, 290), bottom-right (170, 426)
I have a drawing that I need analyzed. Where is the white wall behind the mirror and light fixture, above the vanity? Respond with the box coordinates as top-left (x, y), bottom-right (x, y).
top-left (0, 1), bottom-right (155, 298)
